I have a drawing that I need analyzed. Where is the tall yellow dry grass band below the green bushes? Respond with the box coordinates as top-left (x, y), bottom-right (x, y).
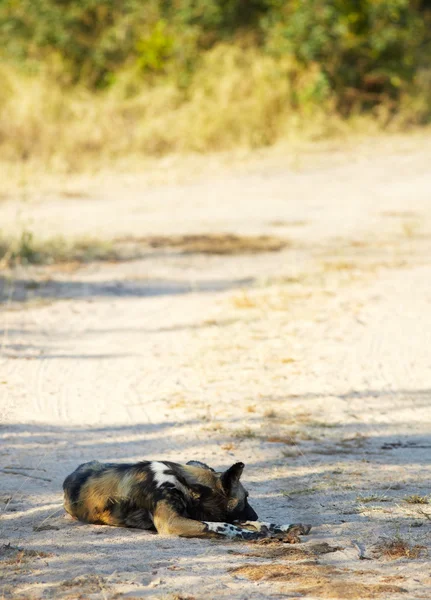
top-left (0, 44), bottom-right (356, 172)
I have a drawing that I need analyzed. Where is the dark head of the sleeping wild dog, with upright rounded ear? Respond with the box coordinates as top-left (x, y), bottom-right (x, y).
top-left (187, 461), bottom-right (258, 523)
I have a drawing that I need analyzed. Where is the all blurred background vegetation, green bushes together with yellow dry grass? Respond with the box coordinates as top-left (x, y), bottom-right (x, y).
top-left (0, 0), bottom-right (431, 169)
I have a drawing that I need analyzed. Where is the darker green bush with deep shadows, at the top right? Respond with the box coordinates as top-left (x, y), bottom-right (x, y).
top-left (264, 0), bottom-right (429, 112)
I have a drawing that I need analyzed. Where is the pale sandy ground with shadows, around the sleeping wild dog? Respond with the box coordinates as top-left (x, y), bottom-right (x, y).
top-left (0, 139), bottom-right (431, 600)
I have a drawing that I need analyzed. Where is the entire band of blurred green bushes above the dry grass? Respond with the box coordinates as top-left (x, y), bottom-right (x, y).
top-left (0, 0), bottom-right (431, 114)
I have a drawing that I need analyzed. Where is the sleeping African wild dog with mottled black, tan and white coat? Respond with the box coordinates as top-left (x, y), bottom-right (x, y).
top-left (63, 461), bottom-right (310, 540)
